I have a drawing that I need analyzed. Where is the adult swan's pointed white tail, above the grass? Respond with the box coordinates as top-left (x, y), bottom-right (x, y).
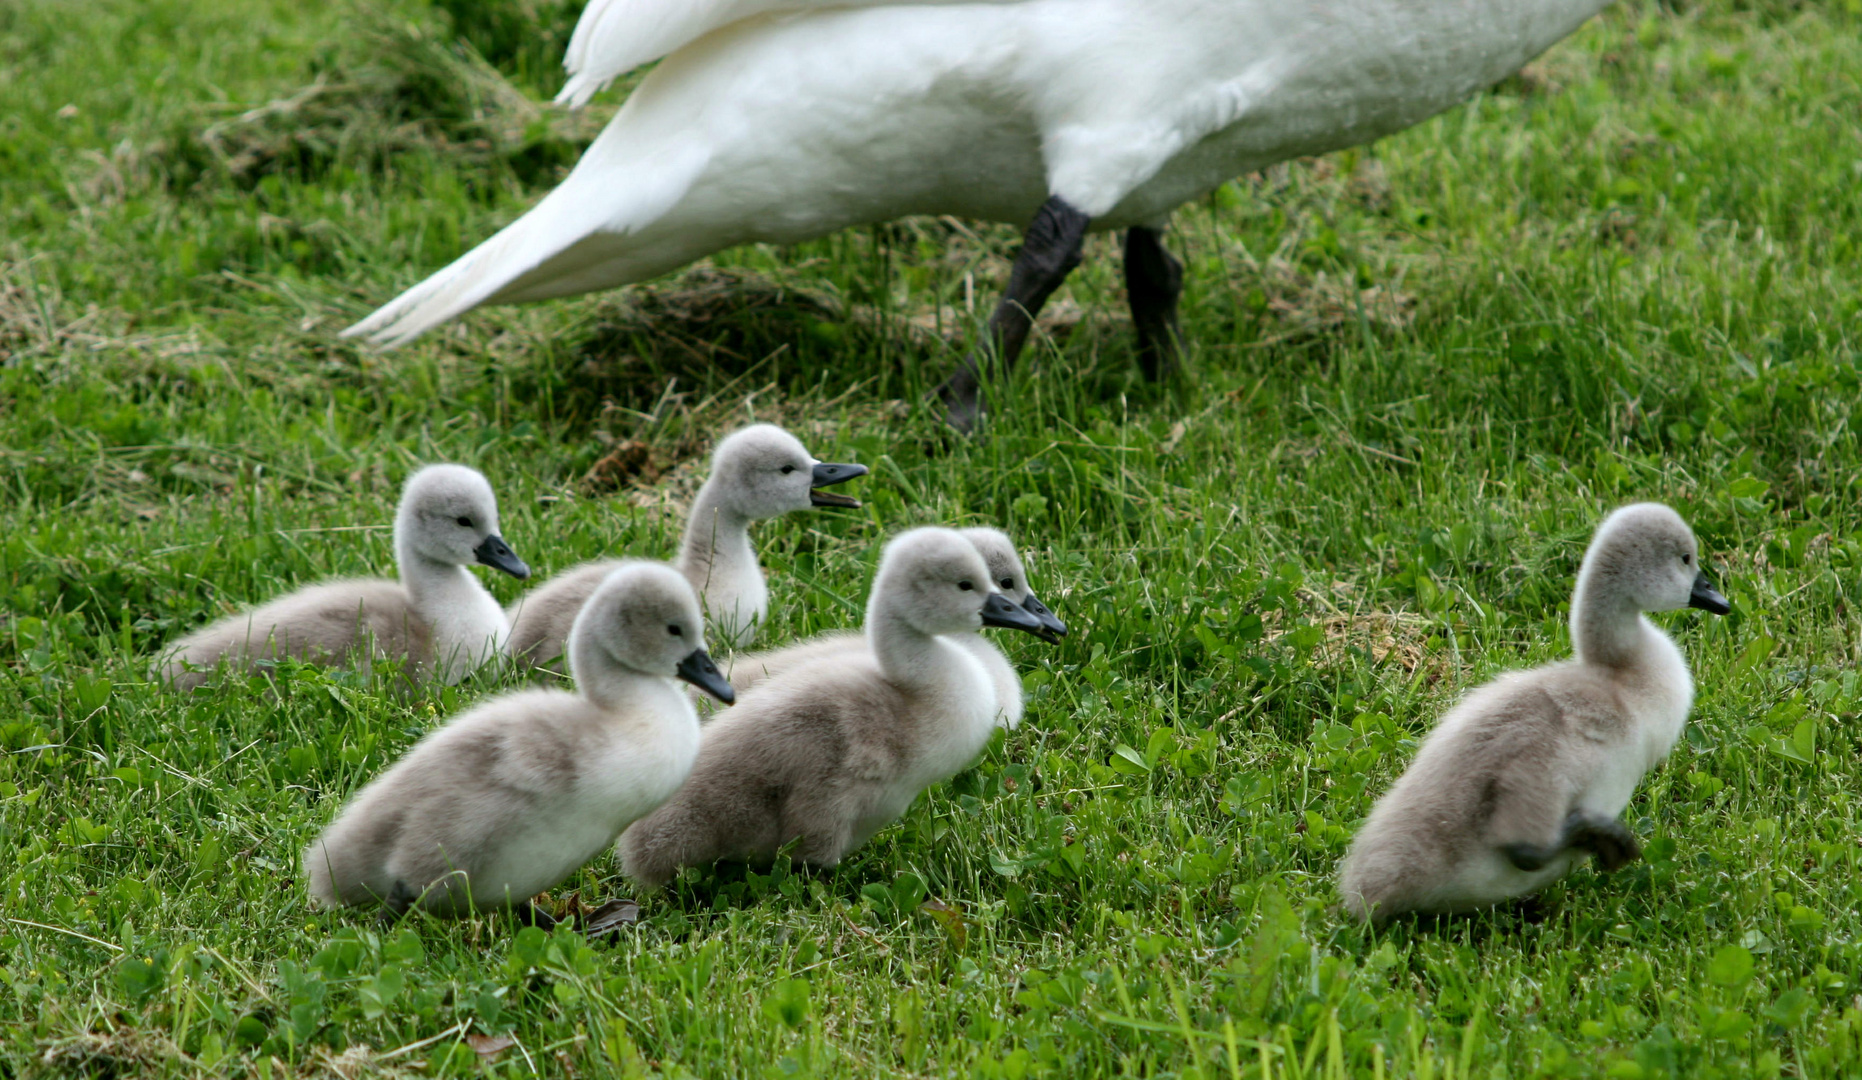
top-left (343, 134), bottom-right (709, 346)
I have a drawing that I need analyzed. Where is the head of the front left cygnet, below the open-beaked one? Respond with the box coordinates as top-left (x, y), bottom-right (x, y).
top-left (568, 560), bottom-right (735, 706)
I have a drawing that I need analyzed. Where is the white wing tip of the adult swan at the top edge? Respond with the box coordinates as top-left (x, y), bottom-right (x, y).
top-left (557, 0), bottom-right (1024, 108)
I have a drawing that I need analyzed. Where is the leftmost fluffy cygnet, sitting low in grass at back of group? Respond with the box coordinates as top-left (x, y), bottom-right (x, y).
top-left (158, 466), bottom-right (531, 689)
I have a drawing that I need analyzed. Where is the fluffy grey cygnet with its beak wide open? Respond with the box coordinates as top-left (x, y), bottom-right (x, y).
top-left (510, 425), bottom-right (866, 665)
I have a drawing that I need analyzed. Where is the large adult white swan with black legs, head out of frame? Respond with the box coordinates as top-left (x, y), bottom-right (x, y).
top-left (346, 0), bottom-right (1609, 426)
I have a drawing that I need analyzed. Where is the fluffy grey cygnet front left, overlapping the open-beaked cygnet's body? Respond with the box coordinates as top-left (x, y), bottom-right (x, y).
top-left (304, 562), bottom-right (732, 916)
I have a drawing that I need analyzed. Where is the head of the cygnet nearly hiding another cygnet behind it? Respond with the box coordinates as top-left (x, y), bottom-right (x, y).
top-left (870, 527), bottom-right (1043, 635)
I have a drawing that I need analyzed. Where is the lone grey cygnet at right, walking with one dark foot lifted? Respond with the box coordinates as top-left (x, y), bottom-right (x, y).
top-left (1339, 503), bottom-right (1730, 922)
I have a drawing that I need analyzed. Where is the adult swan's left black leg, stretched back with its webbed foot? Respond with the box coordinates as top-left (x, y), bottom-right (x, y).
top-left (938, 196), bottom-right (1091, 432)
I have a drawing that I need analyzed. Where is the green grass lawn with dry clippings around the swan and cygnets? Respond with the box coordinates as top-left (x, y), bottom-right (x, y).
top-left (0, 0), bottom-right (1862, 1078)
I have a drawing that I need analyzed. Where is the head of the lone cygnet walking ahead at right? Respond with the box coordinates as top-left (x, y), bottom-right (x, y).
top-left (1577, 503), bottom-right (1732, 614)
